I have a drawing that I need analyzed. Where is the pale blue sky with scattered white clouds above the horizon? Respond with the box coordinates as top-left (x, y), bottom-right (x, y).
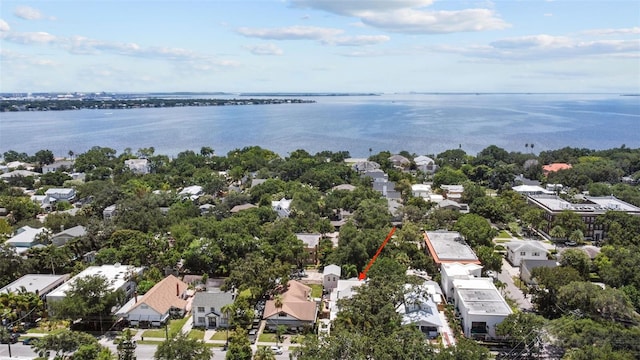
top-left (0, 0), bottom-right (640, 93)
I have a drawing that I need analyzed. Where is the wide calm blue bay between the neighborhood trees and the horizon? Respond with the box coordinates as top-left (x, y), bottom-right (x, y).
top-left (0, 94), bottom-right (640, 157)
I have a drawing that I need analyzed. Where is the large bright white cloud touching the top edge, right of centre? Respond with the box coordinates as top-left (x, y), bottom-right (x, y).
top-left (291, 0), bottom-right (510, 34)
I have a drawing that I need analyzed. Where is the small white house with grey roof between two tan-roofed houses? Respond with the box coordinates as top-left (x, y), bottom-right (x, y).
top-left (191, 289), bottom-right (235, 329)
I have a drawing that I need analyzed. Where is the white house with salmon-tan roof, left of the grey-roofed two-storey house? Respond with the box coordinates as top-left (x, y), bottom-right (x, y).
top-left (117, 275), bottom-right (188, 326)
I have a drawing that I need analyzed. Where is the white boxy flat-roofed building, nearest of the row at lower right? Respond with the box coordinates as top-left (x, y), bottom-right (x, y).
top-left (453, 278), bottom-right (513, 340)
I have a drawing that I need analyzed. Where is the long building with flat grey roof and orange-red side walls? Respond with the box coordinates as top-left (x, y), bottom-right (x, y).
top-left (424, 231), bottom-right (480, 265)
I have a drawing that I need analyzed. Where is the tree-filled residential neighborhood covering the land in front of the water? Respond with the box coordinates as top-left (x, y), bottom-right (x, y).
top-left (0, 146), bottom-right (640, 360)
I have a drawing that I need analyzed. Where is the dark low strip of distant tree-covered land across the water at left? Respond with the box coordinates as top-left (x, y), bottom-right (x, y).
top-left (0, 97), bottom-right (315, 112)
